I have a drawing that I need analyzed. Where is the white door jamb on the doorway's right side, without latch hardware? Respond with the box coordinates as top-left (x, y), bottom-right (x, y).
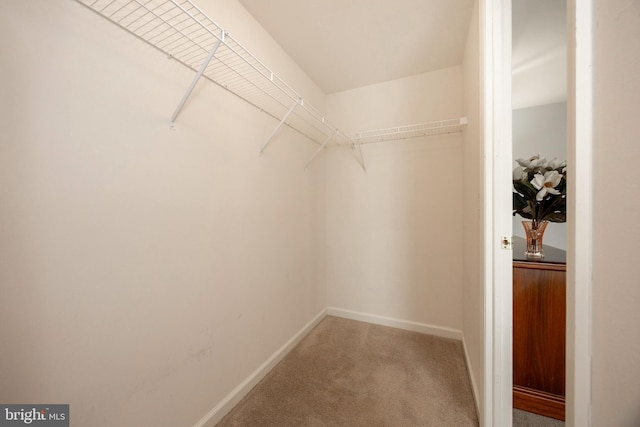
top-left (566, 0), bottom-right (593, 427)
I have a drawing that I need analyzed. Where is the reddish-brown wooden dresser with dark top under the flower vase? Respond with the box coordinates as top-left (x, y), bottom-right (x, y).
top-left (513, 237), bottom-right (566, 421)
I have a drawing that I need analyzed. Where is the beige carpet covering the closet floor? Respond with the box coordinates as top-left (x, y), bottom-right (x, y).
top-left (218, 316), bottom-right (478, 427)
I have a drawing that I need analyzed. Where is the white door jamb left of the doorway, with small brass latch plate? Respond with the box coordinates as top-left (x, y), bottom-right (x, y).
top-left (480, 0), bottom-right (513, 427)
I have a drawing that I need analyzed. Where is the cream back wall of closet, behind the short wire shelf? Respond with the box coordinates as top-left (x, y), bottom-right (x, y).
top-left (326, 67), bottom-right (463, 330)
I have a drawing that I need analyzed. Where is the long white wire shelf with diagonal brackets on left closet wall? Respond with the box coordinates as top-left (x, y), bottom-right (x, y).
top-left (76, 0), bottom-right (354, 157)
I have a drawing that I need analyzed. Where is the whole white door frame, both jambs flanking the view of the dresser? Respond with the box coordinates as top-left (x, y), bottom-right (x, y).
top-left (479, 0), bottom-right (593, 427)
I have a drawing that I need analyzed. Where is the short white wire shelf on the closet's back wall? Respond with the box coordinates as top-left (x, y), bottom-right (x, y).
top-left (351, 117), bottom-right (467, 144)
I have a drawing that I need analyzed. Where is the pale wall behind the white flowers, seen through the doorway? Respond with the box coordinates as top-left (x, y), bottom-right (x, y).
top-left (513, 102), bottom-right (567, 250)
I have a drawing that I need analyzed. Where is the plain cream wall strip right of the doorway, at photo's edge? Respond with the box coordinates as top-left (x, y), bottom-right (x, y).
top-left (592, 0), bottom-right (640, 427)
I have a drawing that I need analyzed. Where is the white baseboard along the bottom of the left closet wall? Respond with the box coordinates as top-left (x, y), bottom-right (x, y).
top-left (194, 308), bottom-right (327, 427)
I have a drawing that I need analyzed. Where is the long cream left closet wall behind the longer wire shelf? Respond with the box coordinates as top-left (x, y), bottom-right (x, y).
top-left (0, 0), bottom-right (327, 427)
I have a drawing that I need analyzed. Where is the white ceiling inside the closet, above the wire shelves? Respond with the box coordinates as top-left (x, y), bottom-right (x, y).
top-left (240, 0), bottom-right (473, 94)
